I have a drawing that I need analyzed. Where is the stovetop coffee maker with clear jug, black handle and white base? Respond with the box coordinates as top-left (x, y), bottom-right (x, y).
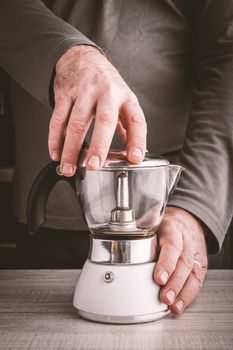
top-left (27, 150), bottom-right (182, 324)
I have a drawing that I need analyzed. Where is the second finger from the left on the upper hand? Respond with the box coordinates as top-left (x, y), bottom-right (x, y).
top-left (61, 96), bottom-right (94, 176)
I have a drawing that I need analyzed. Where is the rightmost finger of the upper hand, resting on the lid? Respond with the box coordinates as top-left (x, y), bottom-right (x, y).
top-left (122, 102), bottom-right (147, 163)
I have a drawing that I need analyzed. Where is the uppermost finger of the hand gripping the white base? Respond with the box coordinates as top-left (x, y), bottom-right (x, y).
top-left (154, 228), bottom-right (183, 285)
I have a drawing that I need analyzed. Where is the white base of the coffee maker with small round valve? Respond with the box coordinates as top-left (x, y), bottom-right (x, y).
top-left (73, 259), bottom-right (169, 324)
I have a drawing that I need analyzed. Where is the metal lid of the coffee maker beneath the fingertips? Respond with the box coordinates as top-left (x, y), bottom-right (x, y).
top-left (79, 149), bottom-right (169, 171)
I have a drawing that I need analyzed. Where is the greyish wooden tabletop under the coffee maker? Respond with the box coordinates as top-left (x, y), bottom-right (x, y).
top-left (0, 270), bottom-right (233, 350)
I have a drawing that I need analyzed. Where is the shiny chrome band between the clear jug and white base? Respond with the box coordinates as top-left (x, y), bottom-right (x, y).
top-left (88, 235), bottom-right (157, 264)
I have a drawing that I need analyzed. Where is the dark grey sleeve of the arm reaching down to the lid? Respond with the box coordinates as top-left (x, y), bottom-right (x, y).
top-left (0, 0), bottom-right (99, 106)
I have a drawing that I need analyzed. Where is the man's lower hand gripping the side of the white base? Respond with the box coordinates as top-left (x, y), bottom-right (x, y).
top-left (154, 207), bottom-right (207, 314)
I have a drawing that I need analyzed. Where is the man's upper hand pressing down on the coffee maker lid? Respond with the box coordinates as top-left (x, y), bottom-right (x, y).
top-left (48, 45), bottom-right (146, 176)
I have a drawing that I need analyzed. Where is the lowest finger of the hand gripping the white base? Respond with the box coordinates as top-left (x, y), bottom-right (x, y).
top-left (170, 264), bottom-right (207, 314)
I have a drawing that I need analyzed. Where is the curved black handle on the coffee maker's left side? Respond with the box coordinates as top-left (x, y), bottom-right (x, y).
top-left (27, 162), bottom-right (76, 234)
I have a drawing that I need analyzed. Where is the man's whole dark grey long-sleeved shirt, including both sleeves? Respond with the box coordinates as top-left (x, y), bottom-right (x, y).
top-left (0, 0), bottom-right (233, 252)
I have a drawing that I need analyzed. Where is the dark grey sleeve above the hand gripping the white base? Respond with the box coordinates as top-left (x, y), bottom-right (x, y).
top-left (169, 0), bottom-right (233, 253)
